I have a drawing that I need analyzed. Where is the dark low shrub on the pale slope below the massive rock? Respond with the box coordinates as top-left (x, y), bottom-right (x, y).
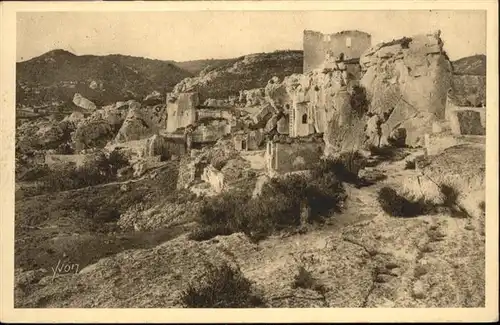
top-left (377, 187), bottom-right (425, 217)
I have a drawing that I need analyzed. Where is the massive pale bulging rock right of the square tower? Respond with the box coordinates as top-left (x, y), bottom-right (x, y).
top-left (360, 32), bottom-right (452, 145)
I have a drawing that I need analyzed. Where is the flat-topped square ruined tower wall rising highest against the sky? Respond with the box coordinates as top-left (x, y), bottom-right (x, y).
top-left (304, 30), bottom-right (371, 73)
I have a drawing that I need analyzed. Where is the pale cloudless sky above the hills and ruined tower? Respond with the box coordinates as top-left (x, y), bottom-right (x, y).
top-left (16, 10), bottom-right (486, 61)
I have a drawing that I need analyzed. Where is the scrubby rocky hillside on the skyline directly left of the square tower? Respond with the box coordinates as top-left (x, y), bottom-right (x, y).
top-left (174, 51), bottom-right (303, 102)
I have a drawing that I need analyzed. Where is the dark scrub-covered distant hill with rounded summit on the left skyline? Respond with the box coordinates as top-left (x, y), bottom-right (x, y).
top-left (16, 50), bottom-right (193, 106)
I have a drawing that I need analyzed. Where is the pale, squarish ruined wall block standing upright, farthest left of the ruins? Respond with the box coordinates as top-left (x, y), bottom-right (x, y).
top-left (167, 92), bottom-right (199, 132)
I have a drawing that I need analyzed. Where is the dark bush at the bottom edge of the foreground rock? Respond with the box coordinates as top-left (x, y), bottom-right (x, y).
top-left (182, 264), bottom-right (263, 308)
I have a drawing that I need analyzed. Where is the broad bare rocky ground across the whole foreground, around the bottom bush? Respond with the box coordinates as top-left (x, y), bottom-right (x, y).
top-left (15, 198), bottom-right (485, 308)
